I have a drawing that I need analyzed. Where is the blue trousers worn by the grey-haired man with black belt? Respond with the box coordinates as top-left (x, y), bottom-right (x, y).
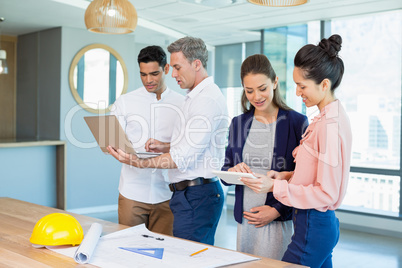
top-left (170, 181), bottom-right (224, 245)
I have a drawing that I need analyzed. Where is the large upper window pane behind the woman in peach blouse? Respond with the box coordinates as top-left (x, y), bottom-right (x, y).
top-left (331, 11), bottom-right (402, 170)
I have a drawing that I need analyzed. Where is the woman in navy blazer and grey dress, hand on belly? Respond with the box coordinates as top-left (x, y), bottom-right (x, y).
top-left (222, 54), bottom-right (308, 260)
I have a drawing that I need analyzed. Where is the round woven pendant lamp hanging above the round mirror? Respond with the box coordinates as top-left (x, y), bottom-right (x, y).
top-left (85, 0), bottom-right (138, 34)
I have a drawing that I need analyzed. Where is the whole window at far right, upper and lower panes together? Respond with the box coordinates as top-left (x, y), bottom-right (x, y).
top-left (331, 10), bottom-right (402, 216)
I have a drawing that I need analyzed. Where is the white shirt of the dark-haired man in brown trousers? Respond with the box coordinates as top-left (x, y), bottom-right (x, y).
top-left (111, 87), bottom-right (184, 204)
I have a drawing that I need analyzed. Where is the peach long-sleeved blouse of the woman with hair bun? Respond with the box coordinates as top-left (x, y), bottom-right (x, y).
top-left (274, 117), bottom-right (344, 211)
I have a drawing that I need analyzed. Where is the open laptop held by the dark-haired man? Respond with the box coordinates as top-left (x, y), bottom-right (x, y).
top-left (84, 115), bottom-right (161, 158)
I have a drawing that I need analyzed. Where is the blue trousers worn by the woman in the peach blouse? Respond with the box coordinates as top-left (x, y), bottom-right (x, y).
top-left (282, 208), bottom-right (339, 268)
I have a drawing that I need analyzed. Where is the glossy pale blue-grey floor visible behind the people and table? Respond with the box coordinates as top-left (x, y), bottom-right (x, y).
top-left (86, 209), bottom-right (402, 268)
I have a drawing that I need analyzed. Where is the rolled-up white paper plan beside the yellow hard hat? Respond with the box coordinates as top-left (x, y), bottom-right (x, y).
top-left (74, 222), bottom-right (102, 264)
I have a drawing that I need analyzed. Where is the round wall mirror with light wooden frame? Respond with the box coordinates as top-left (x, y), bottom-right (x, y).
top-left (69, 44), bottom-right (128, 113)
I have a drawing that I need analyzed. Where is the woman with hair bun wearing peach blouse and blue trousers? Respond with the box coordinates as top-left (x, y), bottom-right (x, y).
top-left (242, 35), bottom-right (352, 268)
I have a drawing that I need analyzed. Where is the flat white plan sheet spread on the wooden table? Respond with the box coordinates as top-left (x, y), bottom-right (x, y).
top-left (52, 224), bottom-right (259, 268)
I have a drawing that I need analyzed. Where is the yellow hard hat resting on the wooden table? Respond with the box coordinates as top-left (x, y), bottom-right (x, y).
top-left (29, 213), bottom-right (84, 246)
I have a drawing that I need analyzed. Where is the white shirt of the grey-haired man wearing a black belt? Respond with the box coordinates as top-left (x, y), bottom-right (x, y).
top-left (169, 77), bottom-right (229, 183)
